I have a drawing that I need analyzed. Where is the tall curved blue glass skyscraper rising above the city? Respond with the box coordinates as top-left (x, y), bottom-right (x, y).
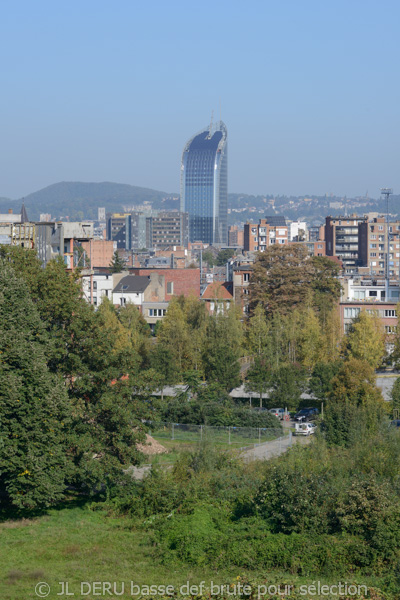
top-left (181, 121), bottom-right (228, 244)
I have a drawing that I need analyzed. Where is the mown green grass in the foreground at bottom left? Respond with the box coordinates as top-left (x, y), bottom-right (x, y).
top-left (0, 502), bottom-right (390, 600)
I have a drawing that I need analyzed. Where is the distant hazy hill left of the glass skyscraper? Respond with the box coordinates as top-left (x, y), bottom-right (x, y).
top-left (0, 181), bottom-right (179, 221)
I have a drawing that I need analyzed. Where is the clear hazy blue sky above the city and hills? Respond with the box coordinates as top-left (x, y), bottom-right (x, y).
top-left (0, 0), bottom-right (400, 198)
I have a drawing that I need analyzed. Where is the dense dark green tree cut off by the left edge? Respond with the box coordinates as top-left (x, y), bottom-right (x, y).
top-left (0, 259), bottom-right (71, 509)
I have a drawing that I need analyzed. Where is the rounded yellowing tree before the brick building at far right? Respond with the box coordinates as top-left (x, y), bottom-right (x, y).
top-left (342, 311), bottom-right (385, 369)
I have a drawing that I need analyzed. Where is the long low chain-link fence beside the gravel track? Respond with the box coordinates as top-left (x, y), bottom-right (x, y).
top-left (151, 423), bottom-right (288, 448)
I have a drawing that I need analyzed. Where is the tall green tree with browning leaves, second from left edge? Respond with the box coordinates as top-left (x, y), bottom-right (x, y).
top-left (1, 249), bottom-right (151, 491)
